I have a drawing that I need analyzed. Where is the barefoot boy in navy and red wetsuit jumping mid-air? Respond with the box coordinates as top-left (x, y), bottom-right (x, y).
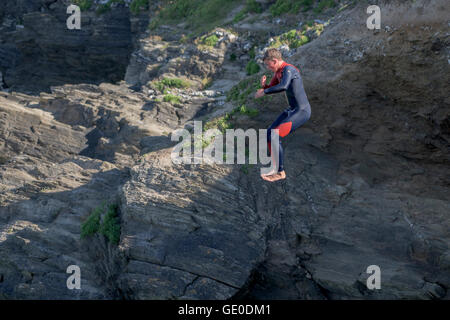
top-left (255, 48), bottom-right (311, 182)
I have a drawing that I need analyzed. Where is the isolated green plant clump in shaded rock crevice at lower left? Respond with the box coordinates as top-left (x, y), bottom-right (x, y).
top-left (81, 202), bottom-right (120, 245)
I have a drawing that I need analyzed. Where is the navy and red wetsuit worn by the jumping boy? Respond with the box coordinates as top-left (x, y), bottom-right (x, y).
top-left (263, 61), bottom-right (311, 172)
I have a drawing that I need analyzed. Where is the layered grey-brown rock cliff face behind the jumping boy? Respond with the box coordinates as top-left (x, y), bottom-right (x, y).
top-left (0, 0), bottom-right (450, 299)
